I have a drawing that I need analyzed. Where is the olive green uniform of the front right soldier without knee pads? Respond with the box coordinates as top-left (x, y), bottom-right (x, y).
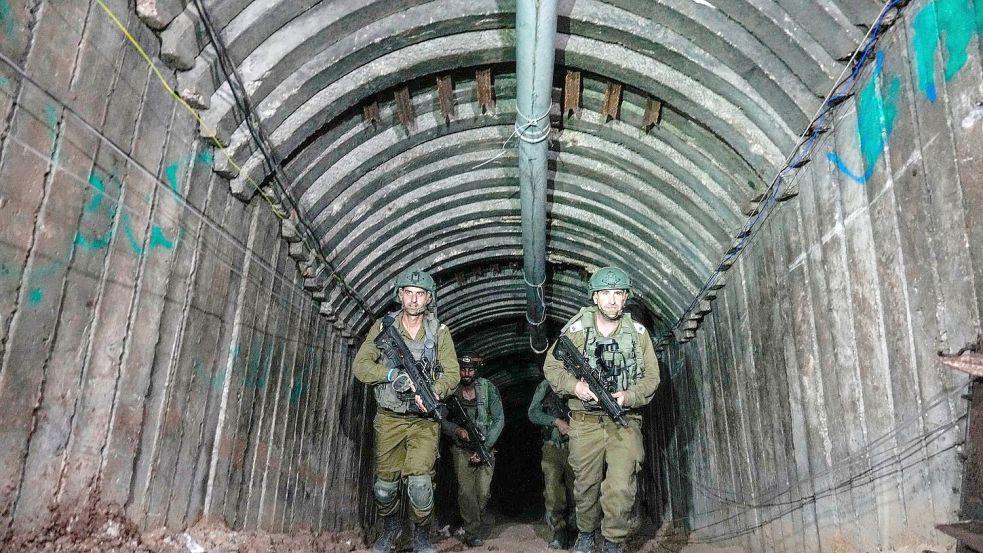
top-left (543, 307), bottom-right (659, 543)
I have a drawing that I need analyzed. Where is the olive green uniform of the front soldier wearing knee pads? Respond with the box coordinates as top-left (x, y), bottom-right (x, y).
top-left (353, 313), bottom-right (461, 525)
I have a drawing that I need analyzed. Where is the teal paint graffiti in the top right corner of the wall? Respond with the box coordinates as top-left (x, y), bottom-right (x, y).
top-left (911, 0), bottom-right (983, 102)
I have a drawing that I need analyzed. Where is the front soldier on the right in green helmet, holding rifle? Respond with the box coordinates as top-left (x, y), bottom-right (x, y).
top-left (543, 267), bottom-right (659, 553)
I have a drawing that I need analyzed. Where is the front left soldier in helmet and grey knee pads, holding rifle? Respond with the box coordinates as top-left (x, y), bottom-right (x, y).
top-left (353, 270), bottom-right (460, 553)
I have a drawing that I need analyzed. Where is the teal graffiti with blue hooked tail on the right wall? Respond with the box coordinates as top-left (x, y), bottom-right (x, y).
top-left (826, 50), bottom-right (901, 184)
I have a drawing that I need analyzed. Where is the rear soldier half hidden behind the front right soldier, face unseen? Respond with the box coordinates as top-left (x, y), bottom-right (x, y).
top-left (529, 380), bottom-right (577, 549)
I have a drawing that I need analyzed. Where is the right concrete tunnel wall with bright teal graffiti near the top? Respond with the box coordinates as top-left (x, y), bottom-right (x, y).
top-left (646, 0), bottom-right (983, 551)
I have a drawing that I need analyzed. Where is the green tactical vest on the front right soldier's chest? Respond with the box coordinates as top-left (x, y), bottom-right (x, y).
top-left (560, 307), bottom-right (645, 392)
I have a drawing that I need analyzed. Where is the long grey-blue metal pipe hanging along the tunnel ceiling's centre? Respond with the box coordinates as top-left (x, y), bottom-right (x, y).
top-left (515, 0), bottom-right (556, 351)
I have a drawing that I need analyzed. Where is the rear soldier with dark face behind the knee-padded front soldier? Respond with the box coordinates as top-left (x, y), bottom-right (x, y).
top-left (441, 353), bottom-right (505, 547)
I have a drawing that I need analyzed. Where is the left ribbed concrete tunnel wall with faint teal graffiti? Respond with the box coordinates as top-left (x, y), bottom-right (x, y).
top-left (0, 0), bottom-right (365, 538)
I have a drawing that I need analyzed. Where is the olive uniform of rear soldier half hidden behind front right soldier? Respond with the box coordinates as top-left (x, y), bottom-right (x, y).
top-left (529, 380), bottom-right (576, 532)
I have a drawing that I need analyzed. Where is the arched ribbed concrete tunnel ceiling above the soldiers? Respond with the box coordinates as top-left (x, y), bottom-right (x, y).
top-left (145, 0), bottom-right (881, 357)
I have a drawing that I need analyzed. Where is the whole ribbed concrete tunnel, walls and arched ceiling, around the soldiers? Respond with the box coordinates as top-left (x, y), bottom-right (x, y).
top-left (0, 0), bottom-right (983, 553)
